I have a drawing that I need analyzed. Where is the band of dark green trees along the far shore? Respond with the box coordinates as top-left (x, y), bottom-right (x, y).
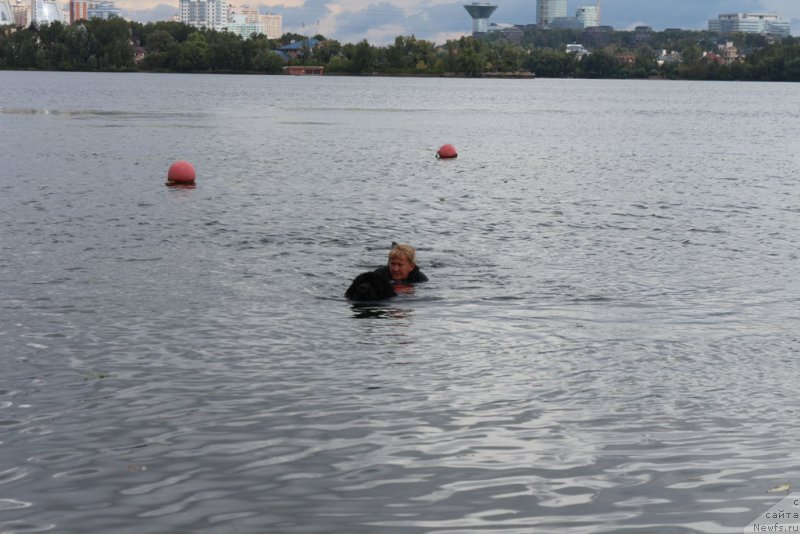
top-left (0, 19), bottom-right (800, 81)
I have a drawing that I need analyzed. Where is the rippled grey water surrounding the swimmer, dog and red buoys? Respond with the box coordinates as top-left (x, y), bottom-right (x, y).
top-left (0, 72), bottom-right (800, 533)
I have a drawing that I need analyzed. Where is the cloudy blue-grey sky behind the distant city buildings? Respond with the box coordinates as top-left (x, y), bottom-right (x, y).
top-left (116, 0), bottom-right (800, 45)
